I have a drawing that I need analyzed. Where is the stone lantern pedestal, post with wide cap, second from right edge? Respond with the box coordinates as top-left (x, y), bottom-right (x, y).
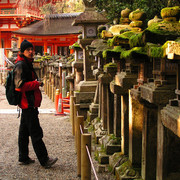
top-left (140, 81), bottom-right (175, 180)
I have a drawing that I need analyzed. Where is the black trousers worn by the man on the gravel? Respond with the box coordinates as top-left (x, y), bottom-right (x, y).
top-left (18, 108), bottom-right (48, 166)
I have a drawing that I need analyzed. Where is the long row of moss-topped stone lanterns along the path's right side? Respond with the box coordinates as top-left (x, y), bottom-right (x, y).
top-left (69, 2), bottom-right (180, 180)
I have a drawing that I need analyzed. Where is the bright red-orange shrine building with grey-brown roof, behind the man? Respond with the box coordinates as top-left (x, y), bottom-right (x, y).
top-left (0, 0), bottom-right (81, 56)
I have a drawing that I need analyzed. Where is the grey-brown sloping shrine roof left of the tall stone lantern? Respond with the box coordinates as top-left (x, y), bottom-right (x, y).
top-left (13, 13), bottom-right (81, 36)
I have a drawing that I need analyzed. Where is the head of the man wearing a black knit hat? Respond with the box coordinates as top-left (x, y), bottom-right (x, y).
top-left (20, 39), bottom-right (34, 58)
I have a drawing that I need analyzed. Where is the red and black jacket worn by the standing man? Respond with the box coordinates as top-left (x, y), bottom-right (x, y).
top-left (14, 55), bottom-right (42, 109)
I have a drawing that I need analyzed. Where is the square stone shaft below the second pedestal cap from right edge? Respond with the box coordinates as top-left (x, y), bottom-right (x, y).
top-left (141, 103), bottom-right (158, 180)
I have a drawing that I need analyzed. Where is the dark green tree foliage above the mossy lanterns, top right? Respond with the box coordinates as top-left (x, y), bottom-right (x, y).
top-left (96, 0), bottom-right (180, 23)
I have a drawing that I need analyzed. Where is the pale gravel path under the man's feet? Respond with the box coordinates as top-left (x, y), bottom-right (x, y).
top-left (0, 85), bottom-right (115, 180)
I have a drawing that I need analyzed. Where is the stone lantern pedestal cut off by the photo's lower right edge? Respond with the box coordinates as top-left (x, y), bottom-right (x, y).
top-left (160, 105), bottom-right (180, 180)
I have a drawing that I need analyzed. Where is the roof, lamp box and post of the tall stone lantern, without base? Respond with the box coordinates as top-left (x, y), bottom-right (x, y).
top-left (73, 0), bottom-right (108, 81)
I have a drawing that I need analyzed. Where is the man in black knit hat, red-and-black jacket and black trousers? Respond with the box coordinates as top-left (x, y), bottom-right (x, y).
top-left (14, 40), bottom-right (58, 168)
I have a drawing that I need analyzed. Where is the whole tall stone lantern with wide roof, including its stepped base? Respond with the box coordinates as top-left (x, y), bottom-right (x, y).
top-left (72, 0), bottom-right (108, 118)
